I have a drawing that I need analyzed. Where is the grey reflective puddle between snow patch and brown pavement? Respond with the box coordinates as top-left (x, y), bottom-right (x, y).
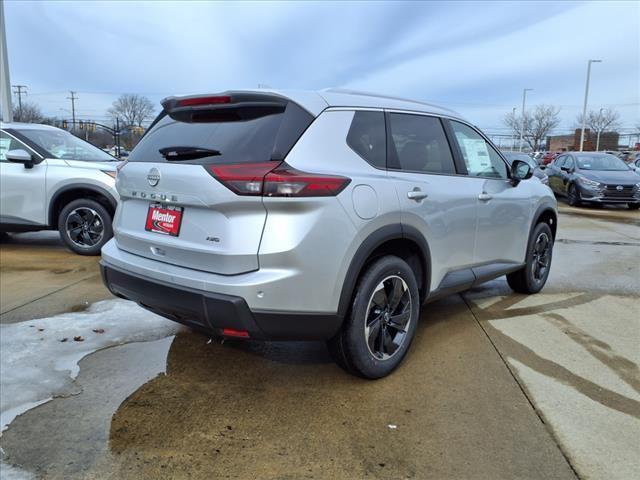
top-left (0, 337), bottom-right (173, 478)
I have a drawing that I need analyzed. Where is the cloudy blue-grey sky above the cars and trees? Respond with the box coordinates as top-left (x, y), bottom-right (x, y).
top-left (5, 0), bottom-right (640, 137)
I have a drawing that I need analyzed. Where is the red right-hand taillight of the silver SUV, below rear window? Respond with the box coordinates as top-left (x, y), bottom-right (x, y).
top-left (205, 162), bottom-right (351, 197)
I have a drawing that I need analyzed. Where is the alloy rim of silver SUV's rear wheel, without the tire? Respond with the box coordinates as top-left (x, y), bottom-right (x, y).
top-left (364, 275), bottom-right (413, 360)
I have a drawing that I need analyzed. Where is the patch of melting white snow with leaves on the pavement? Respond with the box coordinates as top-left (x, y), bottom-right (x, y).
top-left (0, 299), bottom-right (181, 432)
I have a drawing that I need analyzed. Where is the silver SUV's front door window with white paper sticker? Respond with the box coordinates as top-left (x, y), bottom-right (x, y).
top-left (451, 121), bottom-right (508, 178)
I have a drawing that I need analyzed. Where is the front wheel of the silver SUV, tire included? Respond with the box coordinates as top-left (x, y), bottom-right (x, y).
top-left (507, 223), bottom-right (553, 293)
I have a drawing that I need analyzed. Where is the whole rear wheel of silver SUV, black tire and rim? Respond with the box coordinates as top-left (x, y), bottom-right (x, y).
top-left (328, 255), bottom-right (421, 379)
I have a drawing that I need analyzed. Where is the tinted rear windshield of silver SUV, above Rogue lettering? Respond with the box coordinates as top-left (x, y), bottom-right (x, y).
top-left (129, 102), bottom-right (313, 165)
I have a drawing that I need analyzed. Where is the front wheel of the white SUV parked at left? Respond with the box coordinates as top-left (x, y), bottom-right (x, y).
top-left (58, 198), bottom-right (113, 255)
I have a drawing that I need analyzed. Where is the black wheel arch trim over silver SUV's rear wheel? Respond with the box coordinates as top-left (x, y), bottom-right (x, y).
top-left (338, 224), bottom-right (431, 318)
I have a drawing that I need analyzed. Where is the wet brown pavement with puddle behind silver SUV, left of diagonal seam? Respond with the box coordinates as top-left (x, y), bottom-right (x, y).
top-left (1, 297), bottom-right (570, 480)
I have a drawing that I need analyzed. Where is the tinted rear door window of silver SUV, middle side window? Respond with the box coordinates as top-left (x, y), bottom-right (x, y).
top-left (389, 113), bottom-right (456, 174)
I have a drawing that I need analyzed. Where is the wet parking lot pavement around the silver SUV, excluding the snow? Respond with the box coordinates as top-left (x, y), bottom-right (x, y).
top-left (0, 206), bottom-right (640, 479)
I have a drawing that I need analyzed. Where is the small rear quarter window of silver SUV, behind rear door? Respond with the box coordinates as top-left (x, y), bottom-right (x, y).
top-left (347, 112), bottom-right (387, 168)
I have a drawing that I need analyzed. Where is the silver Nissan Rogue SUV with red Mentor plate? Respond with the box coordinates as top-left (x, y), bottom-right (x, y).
top-left (102, 90), bottom-right (557, 378)
